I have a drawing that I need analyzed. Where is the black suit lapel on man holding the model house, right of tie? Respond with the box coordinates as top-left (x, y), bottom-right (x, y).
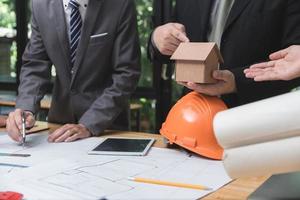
top-left (222, 0), bottom-right (251, 32)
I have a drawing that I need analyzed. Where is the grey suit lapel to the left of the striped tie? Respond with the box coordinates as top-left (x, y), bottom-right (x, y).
top-left (50, 0), bottom-right (71, 71)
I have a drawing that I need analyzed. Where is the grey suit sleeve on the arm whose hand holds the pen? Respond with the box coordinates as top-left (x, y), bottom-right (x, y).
top-left (16, 3), bottom-right (52, 113)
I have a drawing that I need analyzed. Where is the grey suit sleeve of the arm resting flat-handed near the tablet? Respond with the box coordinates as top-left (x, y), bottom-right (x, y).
top-left (79, 0), bottom-right (140, 135)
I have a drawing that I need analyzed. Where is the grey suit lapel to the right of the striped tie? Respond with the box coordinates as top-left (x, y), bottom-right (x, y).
top-left (71, 0), bottom-right (103, 84)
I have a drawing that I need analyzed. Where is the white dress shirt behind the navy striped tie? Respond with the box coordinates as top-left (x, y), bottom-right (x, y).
top-left (63, 0), bottom-right (89, 40)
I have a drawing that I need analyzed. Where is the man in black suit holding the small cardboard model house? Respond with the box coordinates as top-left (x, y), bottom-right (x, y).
top-left (149, 0), bottom-right (300, 107)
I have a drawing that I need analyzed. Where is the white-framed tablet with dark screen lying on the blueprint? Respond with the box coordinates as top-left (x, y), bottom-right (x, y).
top-left (88, 138), bottom-right (155, 156)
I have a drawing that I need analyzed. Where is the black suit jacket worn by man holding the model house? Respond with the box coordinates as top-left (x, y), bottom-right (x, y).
top-left (149, 0), bottom-right (300, 107)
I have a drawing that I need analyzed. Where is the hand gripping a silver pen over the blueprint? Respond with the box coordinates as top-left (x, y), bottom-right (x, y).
top-left (6, 109), bottom-right (35, 144)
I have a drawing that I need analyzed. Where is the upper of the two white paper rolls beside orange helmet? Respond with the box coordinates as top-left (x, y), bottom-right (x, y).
top-left (214, 91), bottom-right (300, 149)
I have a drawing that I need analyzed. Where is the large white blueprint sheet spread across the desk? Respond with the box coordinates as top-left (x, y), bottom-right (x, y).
top-left (0, 134), bottom-right (231, 200)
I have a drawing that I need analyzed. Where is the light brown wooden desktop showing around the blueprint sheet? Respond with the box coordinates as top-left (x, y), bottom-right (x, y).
top-left (43, 124), bottom-right (270, 200)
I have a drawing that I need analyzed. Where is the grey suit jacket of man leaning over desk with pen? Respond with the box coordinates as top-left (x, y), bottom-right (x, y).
top-left (17, 0), bottom-right (140, 135)
